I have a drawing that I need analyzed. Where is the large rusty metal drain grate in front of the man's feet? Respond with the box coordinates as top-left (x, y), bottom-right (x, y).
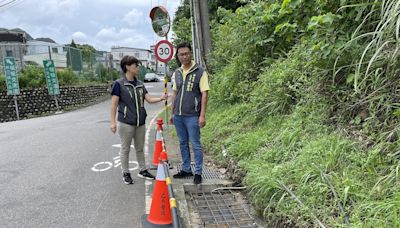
top-left (186, 190), bottom-right (257, 228)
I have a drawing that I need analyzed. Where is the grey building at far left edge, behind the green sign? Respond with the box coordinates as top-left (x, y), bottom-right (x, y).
top-left (0, 30), bottom-right (27, 71)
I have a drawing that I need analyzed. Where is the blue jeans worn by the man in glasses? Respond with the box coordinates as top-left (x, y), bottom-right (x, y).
top-left (174, 115), bottom-right (203, 175)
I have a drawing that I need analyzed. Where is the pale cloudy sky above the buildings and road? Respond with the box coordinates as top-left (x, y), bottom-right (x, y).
top-left (0, 0), bottom-right (180, 51)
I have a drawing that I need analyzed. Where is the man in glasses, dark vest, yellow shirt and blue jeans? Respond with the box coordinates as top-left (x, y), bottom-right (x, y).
top-left (171, 43), bottom-right (210, 184)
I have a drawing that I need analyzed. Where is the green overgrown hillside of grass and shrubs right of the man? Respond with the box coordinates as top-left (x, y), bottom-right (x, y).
top-left (174, 0), bottom-right (400, 227)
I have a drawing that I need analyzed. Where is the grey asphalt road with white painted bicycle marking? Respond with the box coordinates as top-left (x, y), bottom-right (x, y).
top-left (0, 82), bottom-right (170, 227)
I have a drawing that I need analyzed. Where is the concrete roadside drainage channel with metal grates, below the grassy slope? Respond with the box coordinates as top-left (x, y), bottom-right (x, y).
top-left (177, 165), bottom-right (260, 228)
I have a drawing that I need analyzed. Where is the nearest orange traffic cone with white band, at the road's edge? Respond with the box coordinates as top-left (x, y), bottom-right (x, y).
top-left (142, 152), bottom-right (172, 227)
